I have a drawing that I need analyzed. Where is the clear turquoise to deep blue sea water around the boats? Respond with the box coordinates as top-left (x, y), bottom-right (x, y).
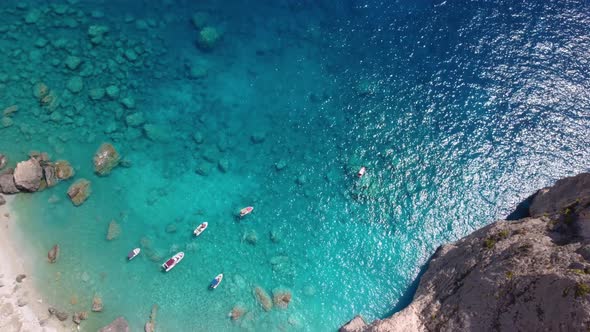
top-left (0, 0), bottom-right (590, 331)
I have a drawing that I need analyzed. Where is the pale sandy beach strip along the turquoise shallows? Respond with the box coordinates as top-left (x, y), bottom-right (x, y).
top-left (0, 195), bottom-right (76, 332)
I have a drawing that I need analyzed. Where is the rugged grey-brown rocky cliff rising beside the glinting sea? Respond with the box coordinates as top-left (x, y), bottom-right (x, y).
top-left (340, 173), bottom-right (590, 332)
